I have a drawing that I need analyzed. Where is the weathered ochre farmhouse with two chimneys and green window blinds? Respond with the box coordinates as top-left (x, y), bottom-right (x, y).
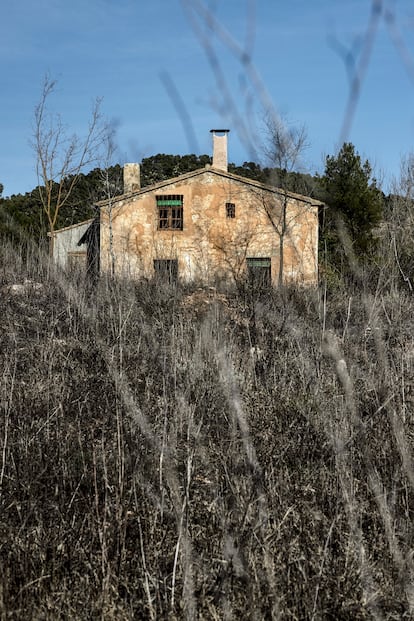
top-left (50, 130), bottom-right (322, 284)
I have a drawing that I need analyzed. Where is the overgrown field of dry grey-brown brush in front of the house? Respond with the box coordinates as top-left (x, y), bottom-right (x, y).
top-left (0, 240), bottom-right (414, 620)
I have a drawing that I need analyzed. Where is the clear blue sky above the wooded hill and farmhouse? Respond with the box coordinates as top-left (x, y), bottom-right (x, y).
top-left (0, 0), bottom-right (414, 196)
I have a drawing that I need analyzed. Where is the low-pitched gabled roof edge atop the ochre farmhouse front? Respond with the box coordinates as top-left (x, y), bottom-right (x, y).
top-left (96, 166), bottom-right (324, 207)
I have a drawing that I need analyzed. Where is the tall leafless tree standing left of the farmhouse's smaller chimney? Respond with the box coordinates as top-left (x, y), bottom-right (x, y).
top-left (32, 76), bottom-right (106, 248)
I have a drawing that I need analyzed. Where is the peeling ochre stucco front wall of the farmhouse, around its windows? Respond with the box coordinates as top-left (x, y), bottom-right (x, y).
top-left (101, 169), bottom-right (318, 284)
